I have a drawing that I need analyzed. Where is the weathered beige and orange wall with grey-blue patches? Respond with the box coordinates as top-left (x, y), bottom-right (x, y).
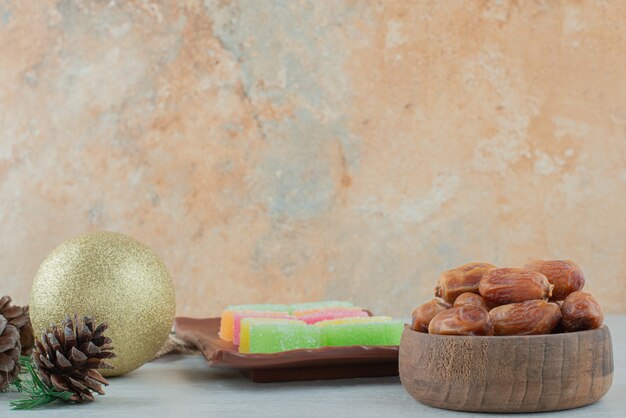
top-left (0, 0), bottom-right (626, 316)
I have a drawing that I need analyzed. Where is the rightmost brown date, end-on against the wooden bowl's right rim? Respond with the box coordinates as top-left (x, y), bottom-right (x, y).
top-left (561, 291), bottom-right (604, 332)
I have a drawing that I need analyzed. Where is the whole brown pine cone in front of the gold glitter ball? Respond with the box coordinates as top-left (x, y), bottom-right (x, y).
top-left (33, 315), bottom-right (115, 402)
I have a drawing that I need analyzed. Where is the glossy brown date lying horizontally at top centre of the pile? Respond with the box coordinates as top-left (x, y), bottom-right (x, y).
top-left (478, 268), bottom-right (554, 306)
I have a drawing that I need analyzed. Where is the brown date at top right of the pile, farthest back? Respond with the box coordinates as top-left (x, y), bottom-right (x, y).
top-left (524, 260), bottom-right (585, 300)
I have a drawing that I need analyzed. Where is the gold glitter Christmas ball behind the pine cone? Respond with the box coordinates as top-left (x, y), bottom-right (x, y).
top-left (30, 232), bottom-right (176, 376)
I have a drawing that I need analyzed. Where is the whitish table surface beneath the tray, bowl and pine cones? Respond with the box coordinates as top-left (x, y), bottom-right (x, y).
top-left (0, 315), bottom-right (626, 418)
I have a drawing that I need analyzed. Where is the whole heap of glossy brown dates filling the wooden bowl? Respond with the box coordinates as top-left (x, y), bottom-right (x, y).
top-left (411, 260), bottom-right (604, 335)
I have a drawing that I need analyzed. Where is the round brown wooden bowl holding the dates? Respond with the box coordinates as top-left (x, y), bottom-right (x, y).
top-left (399, 325), bottom-right (613, 412)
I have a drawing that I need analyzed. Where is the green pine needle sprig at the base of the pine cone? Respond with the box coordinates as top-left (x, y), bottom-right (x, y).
top-left (11, 356), bottom-right (72, 409)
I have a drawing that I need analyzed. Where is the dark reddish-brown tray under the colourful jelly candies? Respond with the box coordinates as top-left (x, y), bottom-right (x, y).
top-left (175, 318), bottom-right (399, 382)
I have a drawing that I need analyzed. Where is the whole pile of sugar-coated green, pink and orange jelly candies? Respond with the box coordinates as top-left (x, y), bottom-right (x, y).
top-left (220, 301), bottom-right (404, 353)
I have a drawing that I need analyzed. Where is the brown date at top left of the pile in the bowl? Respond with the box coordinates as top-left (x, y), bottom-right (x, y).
top-left (435, 263), bottom-right (496, 303)
